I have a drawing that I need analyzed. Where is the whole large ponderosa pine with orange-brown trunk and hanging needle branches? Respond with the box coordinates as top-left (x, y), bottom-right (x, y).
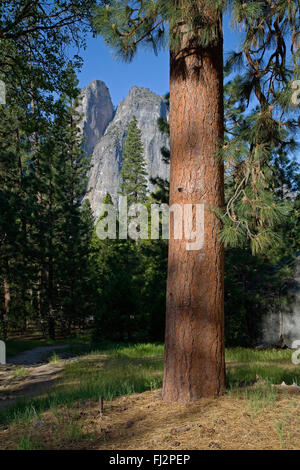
top-left (95, 0), bottom-right (299, 401)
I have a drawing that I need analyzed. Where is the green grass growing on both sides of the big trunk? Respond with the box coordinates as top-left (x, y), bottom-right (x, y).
top-left (0, 342), bottom-right (300, 449)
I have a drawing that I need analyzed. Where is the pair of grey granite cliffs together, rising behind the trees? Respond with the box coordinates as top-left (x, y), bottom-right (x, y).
top-left (80, 81), bottom-right (169, 217)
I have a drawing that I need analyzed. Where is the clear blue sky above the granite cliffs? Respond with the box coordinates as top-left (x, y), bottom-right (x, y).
top-left (78, 17), bottom-right (241, 106)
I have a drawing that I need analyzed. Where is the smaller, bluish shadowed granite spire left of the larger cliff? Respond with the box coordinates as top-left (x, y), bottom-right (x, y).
top-left (78, 80), bottom-right (114, 156)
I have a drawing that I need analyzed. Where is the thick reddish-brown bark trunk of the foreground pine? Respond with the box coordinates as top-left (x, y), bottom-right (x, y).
top-left (163, 20), bottom-right (225, 402)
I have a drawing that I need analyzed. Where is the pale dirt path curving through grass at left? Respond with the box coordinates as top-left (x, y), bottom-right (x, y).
top-left (0, 344), bottom-right (70, 408)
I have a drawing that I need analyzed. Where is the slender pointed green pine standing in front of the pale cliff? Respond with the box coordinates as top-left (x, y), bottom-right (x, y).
top-left (121, 116), bottom-right (147, 205)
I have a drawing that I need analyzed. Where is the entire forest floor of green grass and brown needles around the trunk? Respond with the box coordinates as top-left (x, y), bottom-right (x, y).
top-left (0, 344), bottom-right (300, 450)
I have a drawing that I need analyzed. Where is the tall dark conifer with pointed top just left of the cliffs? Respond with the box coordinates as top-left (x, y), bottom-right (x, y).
top-left (41, 68), bottom-right (90, 337)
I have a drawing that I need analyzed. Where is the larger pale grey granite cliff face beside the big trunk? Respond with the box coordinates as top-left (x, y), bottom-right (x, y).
top-left (88, 87), bottom-right (169, 217)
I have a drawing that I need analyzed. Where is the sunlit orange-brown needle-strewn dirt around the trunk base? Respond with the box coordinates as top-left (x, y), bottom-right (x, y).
top-left (78, 392), bottom-right (300, 450)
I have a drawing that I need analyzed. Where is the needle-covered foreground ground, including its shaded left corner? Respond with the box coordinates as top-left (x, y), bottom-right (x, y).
top-left (0, 389), bottom-right (300, 450)
